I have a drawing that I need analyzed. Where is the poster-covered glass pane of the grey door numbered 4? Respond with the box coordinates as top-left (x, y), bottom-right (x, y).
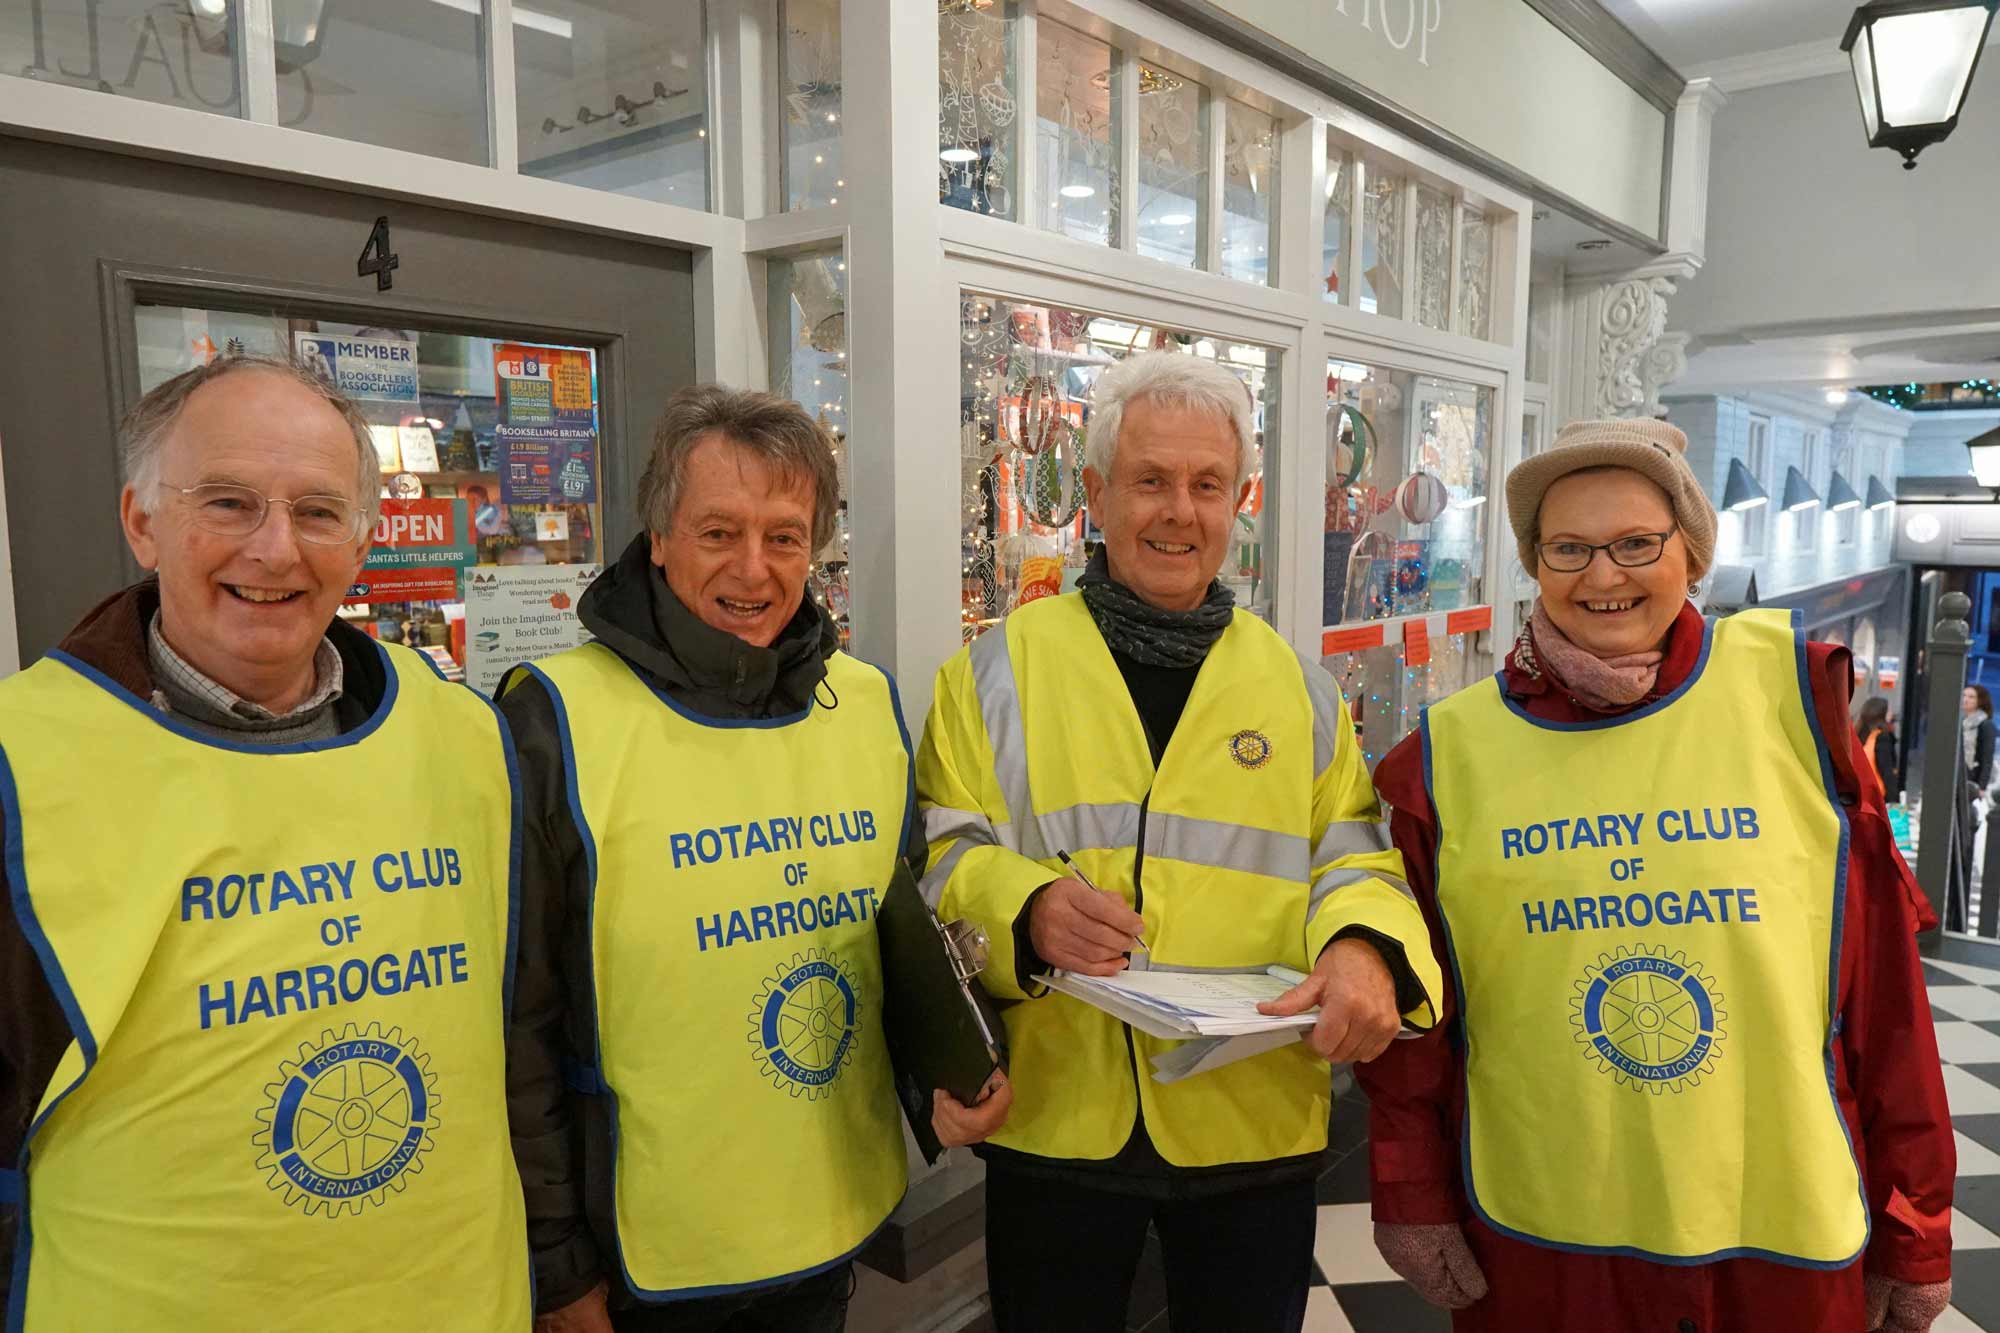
top-left (136, 306), bottom-right (604, 695)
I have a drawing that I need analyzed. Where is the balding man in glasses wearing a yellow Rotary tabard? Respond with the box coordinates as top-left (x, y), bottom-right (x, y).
top-left (0, 356), bottom-right (530, 1333)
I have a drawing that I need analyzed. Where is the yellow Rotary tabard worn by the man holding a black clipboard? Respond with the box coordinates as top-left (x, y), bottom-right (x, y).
top-left (528, 644), bottom-right (910, 1301)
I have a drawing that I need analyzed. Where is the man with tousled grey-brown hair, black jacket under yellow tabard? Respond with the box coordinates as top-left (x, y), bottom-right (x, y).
top-left (502, 384), bottom-right (1010, 1333)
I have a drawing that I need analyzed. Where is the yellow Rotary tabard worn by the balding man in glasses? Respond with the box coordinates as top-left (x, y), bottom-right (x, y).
top-left (0, 648), bottom-right (532, 1333)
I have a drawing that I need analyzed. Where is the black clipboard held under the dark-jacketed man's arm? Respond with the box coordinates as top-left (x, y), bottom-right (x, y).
top-left (876, 857), bottom-right (1006, 1163)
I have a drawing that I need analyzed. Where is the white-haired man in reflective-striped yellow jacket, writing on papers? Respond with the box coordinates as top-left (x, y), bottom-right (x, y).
top-left (916, 352), bottom-right (1440, 1333)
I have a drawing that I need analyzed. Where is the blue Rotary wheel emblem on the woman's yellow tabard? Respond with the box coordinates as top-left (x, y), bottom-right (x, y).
top-left (1570, 945), bottom-right (1728, 1093)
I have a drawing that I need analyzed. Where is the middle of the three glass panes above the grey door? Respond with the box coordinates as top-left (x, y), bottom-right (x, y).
top-left (272, 0), bottom-right (490, 164)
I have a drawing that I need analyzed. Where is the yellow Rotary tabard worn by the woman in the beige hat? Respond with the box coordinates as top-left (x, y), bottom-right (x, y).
top-left (1424, 610), bottom-right (1868, 1267)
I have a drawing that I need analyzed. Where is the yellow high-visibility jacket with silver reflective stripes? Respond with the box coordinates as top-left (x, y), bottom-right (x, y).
top-left (918, 594), bottom-right (1440, 1167)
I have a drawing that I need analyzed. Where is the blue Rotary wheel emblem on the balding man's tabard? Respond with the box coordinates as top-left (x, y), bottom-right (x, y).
top-left (250, 1023), bottom-right (438, 1217)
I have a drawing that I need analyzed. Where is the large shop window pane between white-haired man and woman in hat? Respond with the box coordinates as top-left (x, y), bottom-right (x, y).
top-left (1322, 360), bottom-right (1494, 763)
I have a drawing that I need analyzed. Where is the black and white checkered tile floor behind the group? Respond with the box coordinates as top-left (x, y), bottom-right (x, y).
top-left (976, 941), bottom-right (2000, 1333)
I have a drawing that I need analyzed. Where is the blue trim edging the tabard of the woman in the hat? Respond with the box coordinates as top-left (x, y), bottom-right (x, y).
top-left (1418, 610), bottom-right (1874, 1271)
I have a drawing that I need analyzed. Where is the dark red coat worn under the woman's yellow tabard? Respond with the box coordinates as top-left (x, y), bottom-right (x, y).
top-left (1356, 606), bottom-right (1956, 1333)
